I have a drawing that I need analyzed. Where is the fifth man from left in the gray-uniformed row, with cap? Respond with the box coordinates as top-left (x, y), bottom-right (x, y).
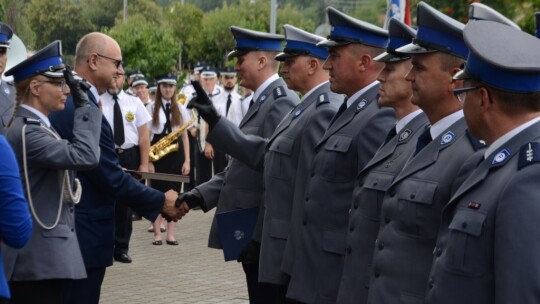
top-left (368, 2), bottom-right (486, 303)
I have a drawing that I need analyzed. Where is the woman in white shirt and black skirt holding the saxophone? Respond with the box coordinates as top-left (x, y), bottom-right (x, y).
top-left (147, 73), bottom-right (191, 245)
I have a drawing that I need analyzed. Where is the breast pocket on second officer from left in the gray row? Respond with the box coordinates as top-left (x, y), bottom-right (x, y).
top-left (265, 136), bottom-right (295, 179)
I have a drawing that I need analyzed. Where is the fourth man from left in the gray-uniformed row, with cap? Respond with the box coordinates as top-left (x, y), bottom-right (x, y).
top-left (337, 19), bottom-right (428, 303)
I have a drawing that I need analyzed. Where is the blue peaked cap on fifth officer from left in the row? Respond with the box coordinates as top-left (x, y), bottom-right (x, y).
top-left (397, 2), bottom-right (469, 59)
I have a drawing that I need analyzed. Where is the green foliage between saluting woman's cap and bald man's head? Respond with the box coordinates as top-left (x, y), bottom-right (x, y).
top-left (26, 0), bottom-right (94, 54)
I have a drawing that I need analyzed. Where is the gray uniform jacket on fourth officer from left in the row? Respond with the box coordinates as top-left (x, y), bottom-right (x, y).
top-left (337, 113), bottom-right (429, 304)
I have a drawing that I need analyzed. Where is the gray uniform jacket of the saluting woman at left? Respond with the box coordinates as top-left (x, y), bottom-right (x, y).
top-left (2, 107), bottom-right (102, 281)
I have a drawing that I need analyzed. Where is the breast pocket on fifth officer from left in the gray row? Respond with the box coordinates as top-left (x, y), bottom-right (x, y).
top-left (397, 179), bottom-right (442, 238)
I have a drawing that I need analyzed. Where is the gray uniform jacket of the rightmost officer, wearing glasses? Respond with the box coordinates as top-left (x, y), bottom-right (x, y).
top-left (426, 122), bottom-right (540, 304)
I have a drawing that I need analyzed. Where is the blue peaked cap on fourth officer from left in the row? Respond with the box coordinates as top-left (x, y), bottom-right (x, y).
top-left (373, 18), bottom-right (416, 62)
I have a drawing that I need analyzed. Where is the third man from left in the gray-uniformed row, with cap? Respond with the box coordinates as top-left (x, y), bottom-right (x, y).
top-left (284, 7), bottom-right (395, 303)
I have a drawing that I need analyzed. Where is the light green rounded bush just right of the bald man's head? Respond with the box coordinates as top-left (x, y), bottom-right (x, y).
top-left (107, 14), bottom-right (180, 79)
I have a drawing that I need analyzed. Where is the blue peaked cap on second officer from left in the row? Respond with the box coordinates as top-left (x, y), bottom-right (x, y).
top-left (276, 24), bottom-right (328, 61)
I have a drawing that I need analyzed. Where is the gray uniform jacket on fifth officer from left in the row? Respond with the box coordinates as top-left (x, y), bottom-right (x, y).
top-left (368, 118), bottom-right (484, 304)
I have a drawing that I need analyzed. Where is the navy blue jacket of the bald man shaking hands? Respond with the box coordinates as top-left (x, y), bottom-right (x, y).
top-left (49, 94), bottom-right (165, 268)
